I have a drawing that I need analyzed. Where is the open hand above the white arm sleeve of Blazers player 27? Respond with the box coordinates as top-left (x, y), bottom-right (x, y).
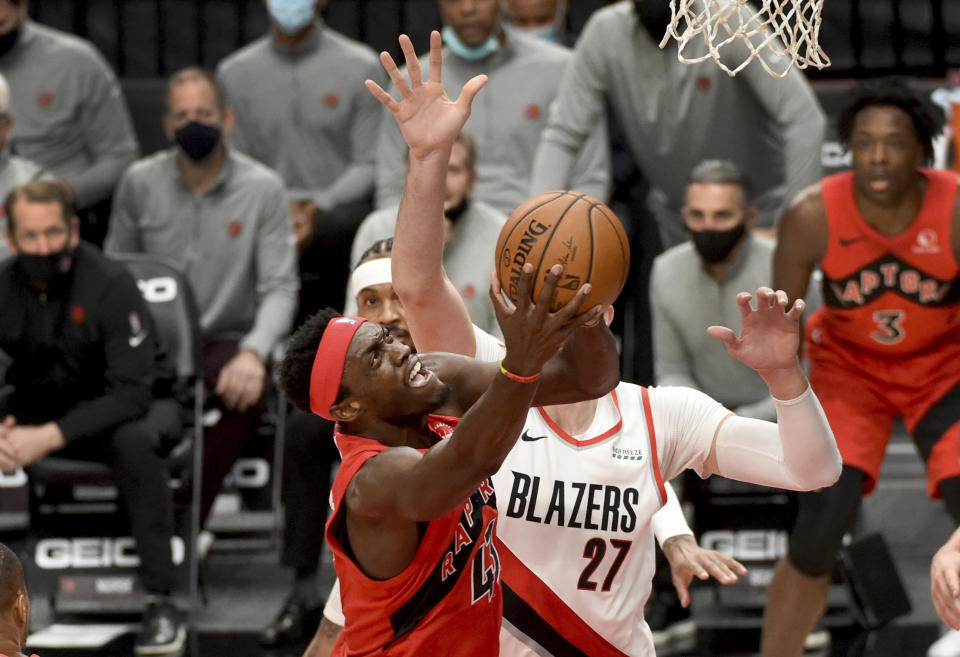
top-left (707, 287), bottom-right (804, 374)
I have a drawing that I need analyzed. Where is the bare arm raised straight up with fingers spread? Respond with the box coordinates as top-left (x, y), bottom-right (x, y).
top-left (367, 31), bottom-right (486, 356)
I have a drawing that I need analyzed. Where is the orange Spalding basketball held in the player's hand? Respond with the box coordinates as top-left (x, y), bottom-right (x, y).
top-left (495, 191), bottom-right (630, 312)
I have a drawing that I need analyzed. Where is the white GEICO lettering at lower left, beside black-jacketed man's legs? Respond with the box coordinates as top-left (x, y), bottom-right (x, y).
top-left (34, 536), bottom-right (185, 570)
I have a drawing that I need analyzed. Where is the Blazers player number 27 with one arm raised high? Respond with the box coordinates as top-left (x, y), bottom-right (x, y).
top-left (368, 28), bottom-right (840, 656)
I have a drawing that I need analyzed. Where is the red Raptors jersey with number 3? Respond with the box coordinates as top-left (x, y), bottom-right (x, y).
top-left (808, 169), bottom-right (960, 356)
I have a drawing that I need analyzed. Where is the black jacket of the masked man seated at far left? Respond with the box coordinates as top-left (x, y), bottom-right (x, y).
top-left (0, 242), bottom-right (159, 442)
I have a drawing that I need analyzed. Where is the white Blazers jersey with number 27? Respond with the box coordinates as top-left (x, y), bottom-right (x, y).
top-left (476, 331), bottom-right (730, 657)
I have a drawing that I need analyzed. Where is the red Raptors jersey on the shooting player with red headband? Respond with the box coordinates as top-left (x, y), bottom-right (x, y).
top-left (326, 415), bottom-right (503, 657)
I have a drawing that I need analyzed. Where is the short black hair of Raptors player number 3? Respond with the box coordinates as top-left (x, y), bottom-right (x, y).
top-left (837, 77), bottom-right (946, 162)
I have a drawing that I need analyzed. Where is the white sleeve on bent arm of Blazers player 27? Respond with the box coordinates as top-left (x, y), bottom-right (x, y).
top-left (716, 386), bottom-right (842, 490)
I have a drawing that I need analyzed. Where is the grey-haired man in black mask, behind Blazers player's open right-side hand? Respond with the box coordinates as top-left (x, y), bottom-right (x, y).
top-left (650, 160), bottom-right (777, 421)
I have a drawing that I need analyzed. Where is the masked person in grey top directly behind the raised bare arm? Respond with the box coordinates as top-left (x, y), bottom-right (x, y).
top-left (346, 132), bottom-right (507, 335)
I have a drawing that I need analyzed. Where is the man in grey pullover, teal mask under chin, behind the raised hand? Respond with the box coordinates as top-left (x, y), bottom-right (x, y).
top-left (376, 0), bottom-right (610, 217)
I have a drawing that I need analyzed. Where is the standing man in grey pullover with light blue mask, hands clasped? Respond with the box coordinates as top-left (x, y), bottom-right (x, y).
top-left (216, 0), bottom-right (382, 319)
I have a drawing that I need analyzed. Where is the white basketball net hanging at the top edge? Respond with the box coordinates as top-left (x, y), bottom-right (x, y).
top-left (660, 0), bottom-right (830, 78)
